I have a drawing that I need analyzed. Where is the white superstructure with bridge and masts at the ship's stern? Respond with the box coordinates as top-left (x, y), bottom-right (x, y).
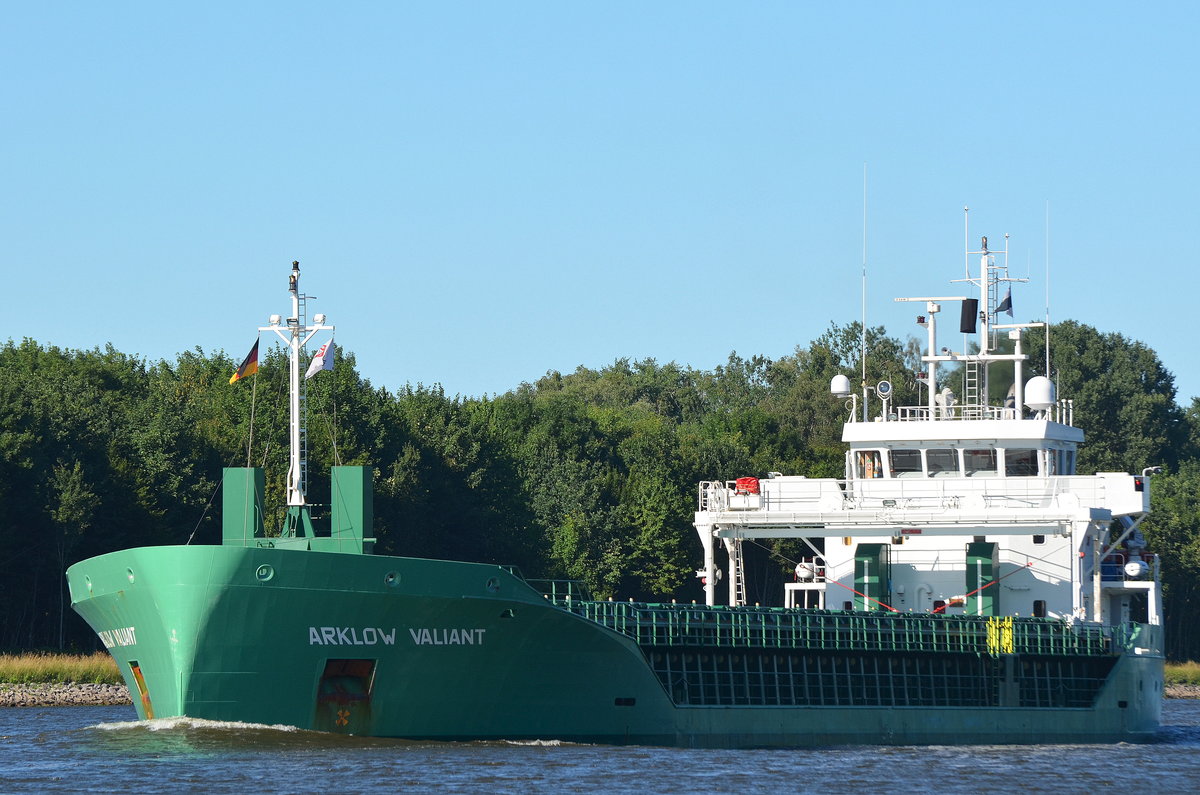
top-left (695, 238), bottom-right (1162, 624)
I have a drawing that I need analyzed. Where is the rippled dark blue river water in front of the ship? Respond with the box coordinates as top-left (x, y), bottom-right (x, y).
top-left (7, 699), bottom-right (1200, 795)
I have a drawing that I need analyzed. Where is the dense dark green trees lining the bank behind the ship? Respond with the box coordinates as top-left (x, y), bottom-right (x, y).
top-left (0, 322), bottom-right (1200, 660)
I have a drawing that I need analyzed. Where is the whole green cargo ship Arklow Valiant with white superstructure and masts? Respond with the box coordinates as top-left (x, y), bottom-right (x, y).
top-left (67, 238), bottom-right (1163, 748)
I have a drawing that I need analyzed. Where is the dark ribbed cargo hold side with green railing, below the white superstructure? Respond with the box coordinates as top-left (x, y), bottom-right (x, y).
top-left (557, 599), bottom-right (1159, 709)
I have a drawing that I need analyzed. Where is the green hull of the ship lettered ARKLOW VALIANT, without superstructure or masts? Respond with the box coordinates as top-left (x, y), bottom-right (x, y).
top-left (67, 545), bottom-right (1163, 748)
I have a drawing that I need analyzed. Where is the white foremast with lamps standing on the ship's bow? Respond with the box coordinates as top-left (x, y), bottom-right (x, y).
top-left (258, 262), bottom-right (334, 537)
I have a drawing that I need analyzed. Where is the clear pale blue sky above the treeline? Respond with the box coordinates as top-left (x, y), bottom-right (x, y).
top-left (0, 1), bottom-right (1200, 405)
